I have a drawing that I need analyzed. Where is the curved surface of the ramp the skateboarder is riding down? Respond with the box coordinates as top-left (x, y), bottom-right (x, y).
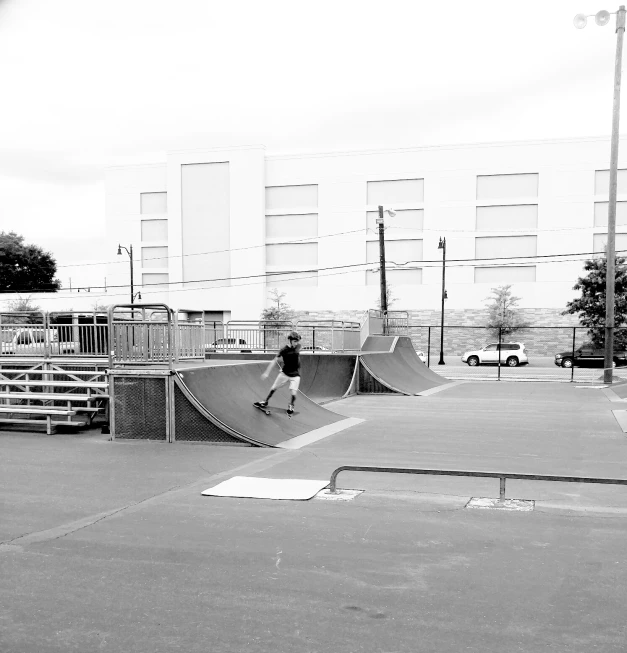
top-left (176, 362), bottom-right (361, 448)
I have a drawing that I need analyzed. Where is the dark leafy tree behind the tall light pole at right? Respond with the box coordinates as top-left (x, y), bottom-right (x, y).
top-left (562, 252), bottom-right (627, 349)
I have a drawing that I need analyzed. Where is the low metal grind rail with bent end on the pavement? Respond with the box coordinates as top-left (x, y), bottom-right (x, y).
top-left (329, 465), bottom-right (627, 501)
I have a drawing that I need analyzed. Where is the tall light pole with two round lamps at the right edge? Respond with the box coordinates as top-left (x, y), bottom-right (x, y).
top-left (573, 5), bottom-right (627, 383)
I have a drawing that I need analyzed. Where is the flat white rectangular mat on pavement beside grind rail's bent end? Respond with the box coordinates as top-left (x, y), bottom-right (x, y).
top-left (202, 476), bottom-right (329, 501)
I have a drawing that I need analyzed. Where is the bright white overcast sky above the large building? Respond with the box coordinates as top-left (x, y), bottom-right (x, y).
top-left (0, 0), bottom-right (627, 287)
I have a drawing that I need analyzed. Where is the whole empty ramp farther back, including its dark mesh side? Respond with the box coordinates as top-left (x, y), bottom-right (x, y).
top-left (359, 336), bottom-right (450, 395)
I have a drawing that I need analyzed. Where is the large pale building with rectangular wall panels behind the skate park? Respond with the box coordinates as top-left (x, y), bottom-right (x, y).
top-left (106, 138), bottom-right (627, 321)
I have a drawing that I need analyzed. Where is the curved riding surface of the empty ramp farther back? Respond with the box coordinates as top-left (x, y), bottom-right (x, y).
top-left (360, 336), bottom-right (449, 395)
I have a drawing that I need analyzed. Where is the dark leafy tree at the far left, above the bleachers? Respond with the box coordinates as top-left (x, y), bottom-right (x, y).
top-left (0, 231), bottom-right (61, 292)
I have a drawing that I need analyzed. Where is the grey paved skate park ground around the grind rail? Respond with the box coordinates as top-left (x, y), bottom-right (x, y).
top-left (0, 382), bottom-right (627, 653)
